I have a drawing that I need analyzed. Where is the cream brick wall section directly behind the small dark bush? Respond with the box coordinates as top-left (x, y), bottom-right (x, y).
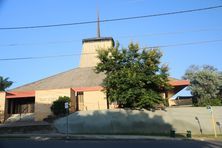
top-left (35, 88), bottom-right (71, 121)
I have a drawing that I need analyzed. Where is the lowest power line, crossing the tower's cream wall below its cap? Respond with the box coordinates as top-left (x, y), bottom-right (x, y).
top-left (0, 39), bottom-right (222, 61)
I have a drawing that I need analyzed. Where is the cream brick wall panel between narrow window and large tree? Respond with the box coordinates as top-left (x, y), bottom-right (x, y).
top-left (84, 91), bottom-right (107, 110)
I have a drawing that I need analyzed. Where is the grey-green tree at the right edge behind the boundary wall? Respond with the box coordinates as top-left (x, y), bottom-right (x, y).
top-left (183, 65), bottom-right (222, 106)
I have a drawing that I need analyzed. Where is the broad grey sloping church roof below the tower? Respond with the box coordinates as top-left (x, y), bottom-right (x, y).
top-left (10, 67), bottom-right (105, 91)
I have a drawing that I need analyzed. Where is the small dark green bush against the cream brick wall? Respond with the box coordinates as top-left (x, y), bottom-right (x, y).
top-left (50, 96), bottom-right (70, 116)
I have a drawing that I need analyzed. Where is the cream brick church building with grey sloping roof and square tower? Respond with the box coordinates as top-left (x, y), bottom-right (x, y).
top-left (0, 21), bottom-right (189, 121)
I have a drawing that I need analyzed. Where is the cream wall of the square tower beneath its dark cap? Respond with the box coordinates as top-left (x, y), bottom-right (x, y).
top-left (79, 40), bottom-right (113, 67)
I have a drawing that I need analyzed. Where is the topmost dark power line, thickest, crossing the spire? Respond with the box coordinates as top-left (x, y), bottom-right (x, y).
top-left (0, 5), bottom-right (222, 30)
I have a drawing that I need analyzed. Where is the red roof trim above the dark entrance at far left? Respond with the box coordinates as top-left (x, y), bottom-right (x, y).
top-left (6, 91), bottom-right (35, 99)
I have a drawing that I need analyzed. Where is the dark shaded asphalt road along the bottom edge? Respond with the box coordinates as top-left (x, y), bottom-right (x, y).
top-left (0, 139), bottom-right (222, 148)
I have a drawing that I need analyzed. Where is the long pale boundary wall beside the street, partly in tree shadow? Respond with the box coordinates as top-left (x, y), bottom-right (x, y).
top-left (54, 107), bottom-right (222, 135)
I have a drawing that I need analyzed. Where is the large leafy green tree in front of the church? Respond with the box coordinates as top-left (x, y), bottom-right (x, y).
top-left (95, 43), bottom-right (170, 109)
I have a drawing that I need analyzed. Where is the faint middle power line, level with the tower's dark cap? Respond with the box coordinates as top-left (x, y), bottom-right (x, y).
top-left (0, 28), bottom-right (222, 47)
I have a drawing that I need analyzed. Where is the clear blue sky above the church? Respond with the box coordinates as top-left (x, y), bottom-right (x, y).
top-left (0, 0), bottom-right (222, 95)
